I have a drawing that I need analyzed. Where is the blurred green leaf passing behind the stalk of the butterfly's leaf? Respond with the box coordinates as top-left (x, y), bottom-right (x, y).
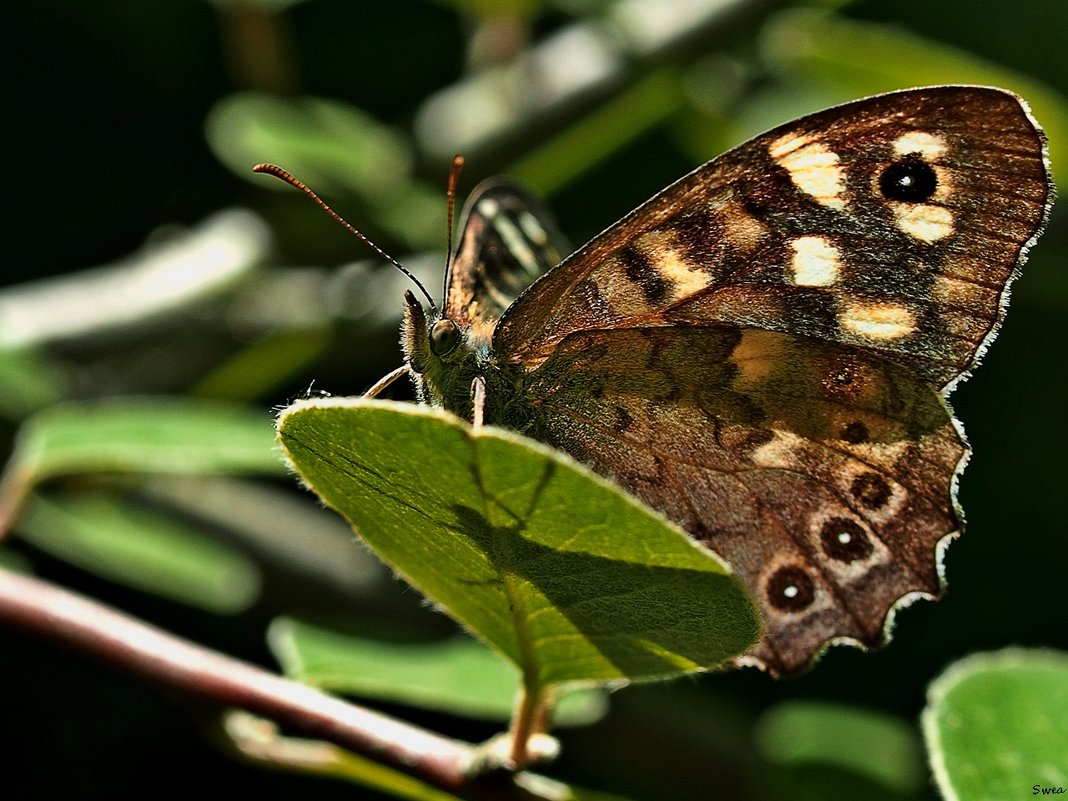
top-left (268, 617), bottom-right (607, 725)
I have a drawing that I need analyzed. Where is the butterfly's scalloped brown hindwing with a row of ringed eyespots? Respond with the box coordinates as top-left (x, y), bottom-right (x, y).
top-left (525, 327), bottom-right (965, 673)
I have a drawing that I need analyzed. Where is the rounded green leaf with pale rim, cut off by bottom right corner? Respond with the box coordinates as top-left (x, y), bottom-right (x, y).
top-left (923, 648), bottom-right (1068, 801)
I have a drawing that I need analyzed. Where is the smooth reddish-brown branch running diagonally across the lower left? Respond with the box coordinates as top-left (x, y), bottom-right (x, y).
top-left (0, 569), bottom-right (568, 801)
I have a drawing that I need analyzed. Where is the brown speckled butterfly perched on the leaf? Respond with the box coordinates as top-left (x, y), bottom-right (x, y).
top-left (264, 87), bottom-right (1052, 673)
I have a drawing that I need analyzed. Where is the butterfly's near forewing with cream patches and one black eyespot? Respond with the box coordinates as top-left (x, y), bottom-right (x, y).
top-left (494, 87), bottom-right (1049, 384)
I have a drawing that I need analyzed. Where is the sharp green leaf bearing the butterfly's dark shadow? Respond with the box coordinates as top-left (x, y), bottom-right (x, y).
top-left (279, 398), bottom-right (758, 689)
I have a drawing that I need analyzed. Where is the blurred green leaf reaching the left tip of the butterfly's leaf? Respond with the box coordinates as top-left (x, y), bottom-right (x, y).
top-left (10, 398), bottom-right (285, 482)
